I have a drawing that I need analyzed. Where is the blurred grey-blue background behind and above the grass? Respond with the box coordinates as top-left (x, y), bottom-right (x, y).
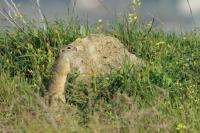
top-left (0, 0), bottom-right (200, 32)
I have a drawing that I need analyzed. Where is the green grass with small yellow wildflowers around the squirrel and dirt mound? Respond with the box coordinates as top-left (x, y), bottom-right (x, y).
top-left (0, 13), bottom-right (200, 133)
